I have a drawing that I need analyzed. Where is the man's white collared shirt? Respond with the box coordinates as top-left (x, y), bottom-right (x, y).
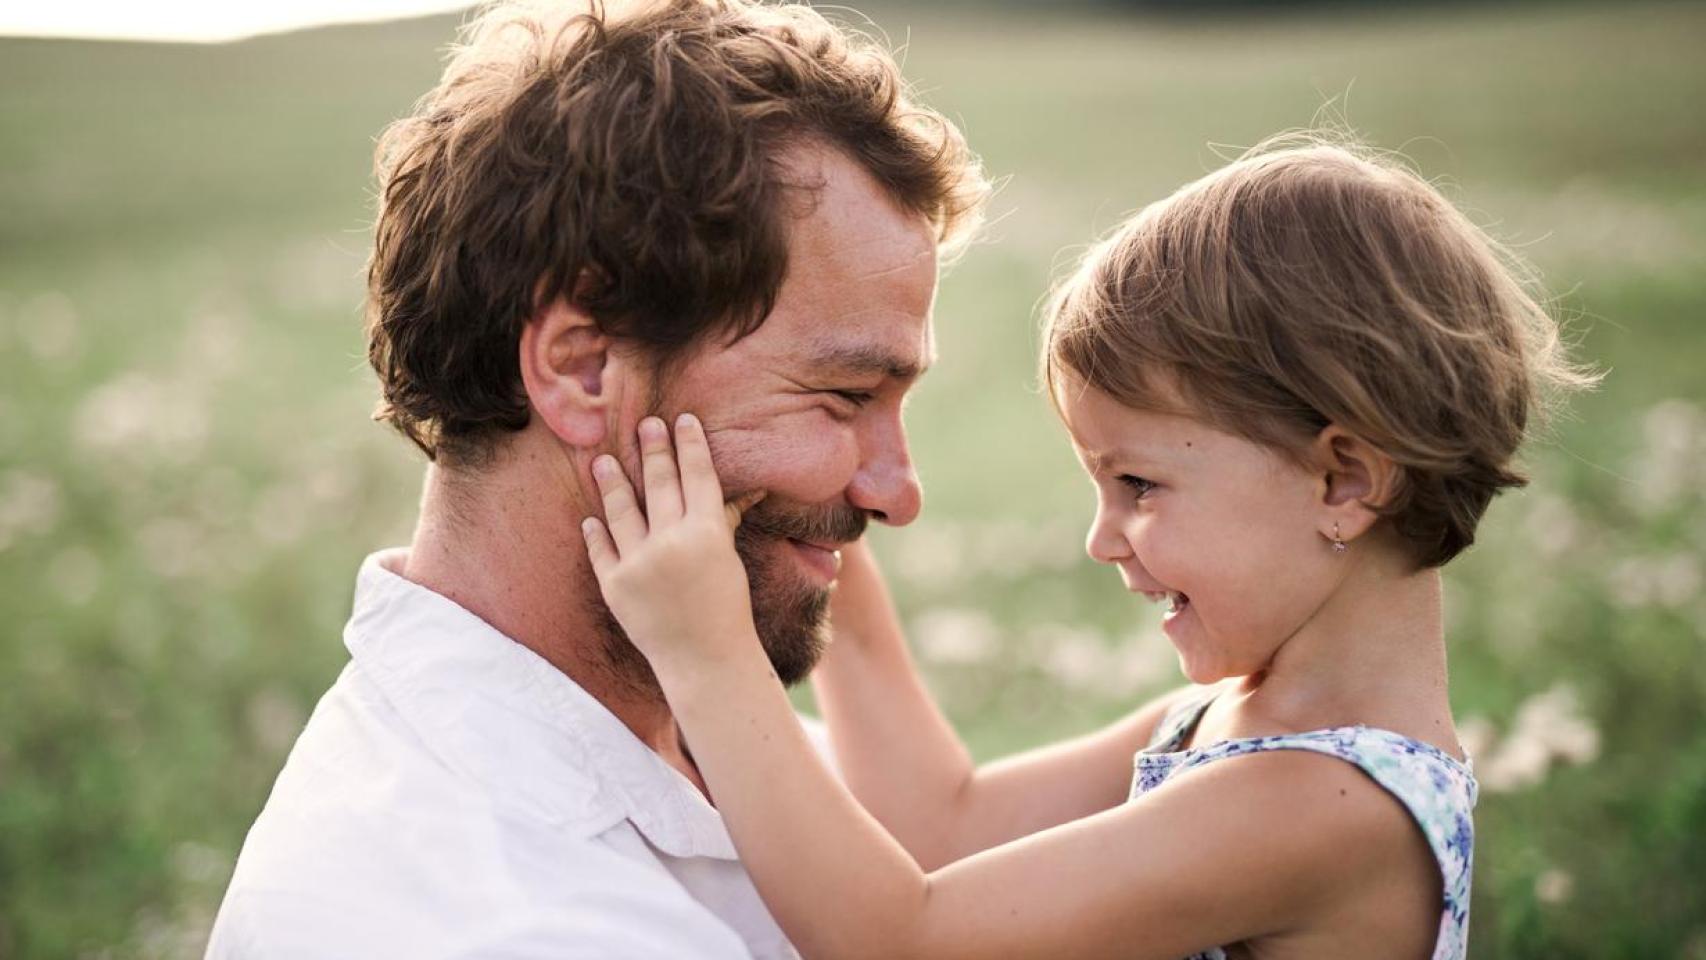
top-left (208, 551), bottom-right (822, 960)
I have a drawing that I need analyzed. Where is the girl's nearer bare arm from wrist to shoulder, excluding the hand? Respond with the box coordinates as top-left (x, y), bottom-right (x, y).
top-left (659, 636), bottom-right (1398, 960)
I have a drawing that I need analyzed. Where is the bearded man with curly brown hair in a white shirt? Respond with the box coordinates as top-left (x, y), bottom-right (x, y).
top-left (210, 0), bottom-right (986, 958)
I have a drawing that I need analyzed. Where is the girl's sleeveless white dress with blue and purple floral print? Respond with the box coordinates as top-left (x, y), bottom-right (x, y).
top-left (1131, 692), bottom-right (1476, 960)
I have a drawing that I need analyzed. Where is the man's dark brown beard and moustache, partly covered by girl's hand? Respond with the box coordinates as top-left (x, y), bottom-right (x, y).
top-left (594, 498), bottom-right (868, 694)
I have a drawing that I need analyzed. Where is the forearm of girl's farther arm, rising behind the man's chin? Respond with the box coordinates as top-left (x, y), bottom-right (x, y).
top-left (812, 541), bottom-right (976, 870)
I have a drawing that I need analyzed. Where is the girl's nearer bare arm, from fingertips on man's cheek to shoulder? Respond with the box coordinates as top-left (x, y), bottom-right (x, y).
top-left (585, 418), bottom-right (1419, 960)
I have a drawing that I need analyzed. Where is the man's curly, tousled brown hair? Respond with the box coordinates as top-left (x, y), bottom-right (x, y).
top-left (367, 0), bottom-right (988, 464)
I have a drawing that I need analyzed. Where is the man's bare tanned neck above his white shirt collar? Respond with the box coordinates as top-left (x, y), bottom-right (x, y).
top-left (401, 466), bottom-right (705, 793)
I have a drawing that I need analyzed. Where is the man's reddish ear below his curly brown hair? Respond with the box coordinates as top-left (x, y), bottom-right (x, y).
top-left (520, 297), bottom-right (611, 448)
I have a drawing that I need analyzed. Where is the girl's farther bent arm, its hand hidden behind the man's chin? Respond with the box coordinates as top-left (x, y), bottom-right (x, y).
top-left (812, 541), bottom-right (1179, 870)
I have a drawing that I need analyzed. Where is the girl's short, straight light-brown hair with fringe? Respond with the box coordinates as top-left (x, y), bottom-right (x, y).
top-left (1042, 133), bottom-right (1597, 566)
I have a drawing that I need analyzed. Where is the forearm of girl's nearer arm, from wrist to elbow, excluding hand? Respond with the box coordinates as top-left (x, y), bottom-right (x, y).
top-left (659, 639), bottom-right (928, 958)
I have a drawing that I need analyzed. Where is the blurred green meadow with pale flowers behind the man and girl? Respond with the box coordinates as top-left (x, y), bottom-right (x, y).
top-left (0, 3), bottom-right (1706, 958)
